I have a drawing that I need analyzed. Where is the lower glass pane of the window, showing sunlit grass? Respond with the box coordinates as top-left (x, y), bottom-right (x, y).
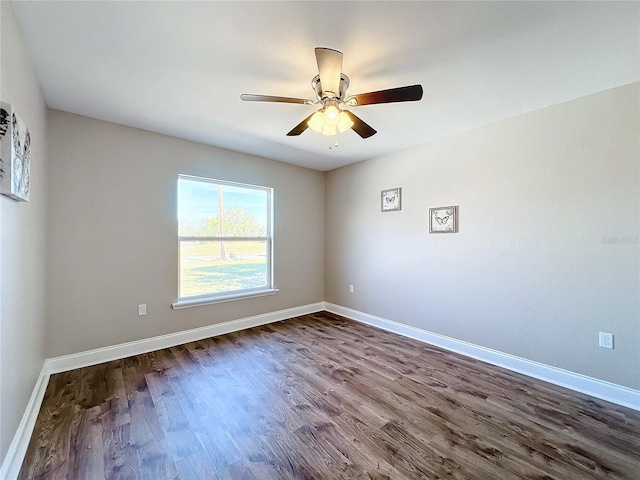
top-left (180, 240), bottom-right (269, 298)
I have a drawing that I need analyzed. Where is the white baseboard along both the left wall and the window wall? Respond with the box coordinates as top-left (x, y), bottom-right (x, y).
top-left (0, 302), bottom-right (324, 480)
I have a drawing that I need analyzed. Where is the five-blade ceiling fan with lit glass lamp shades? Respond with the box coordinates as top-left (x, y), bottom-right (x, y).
top-left (240, 47), bottom-right (422, 145)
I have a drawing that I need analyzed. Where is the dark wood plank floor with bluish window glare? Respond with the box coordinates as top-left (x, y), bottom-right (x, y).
top-left (20, 312), bottom-right (640, 480)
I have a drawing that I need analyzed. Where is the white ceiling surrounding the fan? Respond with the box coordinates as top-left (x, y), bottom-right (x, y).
top-left (14, 1), bottom-right (640, 170)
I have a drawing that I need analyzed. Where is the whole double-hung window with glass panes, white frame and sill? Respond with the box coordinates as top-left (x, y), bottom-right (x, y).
top-left (173, 175), bottom-right (277, 308)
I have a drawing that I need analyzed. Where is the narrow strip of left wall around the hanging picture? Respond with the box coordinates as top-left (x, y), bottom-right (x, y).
top-left (0, 2), bottom-right (47, 463)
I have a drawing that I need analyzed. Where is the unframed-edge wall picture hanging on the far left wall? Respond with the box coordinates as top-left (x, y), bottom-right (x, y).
top-left (0, 102), bottom-right (31, 202)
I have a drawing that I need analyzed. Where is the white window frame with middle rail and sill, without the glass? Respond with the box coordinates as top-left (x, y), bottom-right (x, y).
top-left (171, 174), bottom-right (278, 310)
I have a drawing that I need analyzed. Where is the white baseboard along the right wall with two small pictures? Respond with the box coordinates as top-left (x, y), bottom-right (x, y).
top-left (324, 302), bottom-right (640, 411)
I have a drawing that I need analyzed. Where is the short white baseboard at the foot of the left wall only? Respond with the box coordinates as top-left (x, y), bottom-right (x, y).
top-left (0, 364), bottom-right (50, 480)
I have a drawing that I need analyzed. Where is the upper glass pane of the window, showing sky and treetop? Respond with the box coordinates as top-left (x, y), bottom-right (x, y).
top-left (178, 178), bottom-right (269, 237)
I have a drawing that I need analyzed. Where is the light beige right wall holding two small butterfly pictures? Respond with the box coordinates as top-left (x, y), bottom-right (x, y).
top-left (325, 83), bottom-right (640, 389)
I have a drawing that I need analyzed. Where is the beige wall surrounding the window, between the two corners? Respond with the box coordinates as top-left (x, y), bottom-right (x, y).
top-left (47, 111), bottom-right (324, 357)
